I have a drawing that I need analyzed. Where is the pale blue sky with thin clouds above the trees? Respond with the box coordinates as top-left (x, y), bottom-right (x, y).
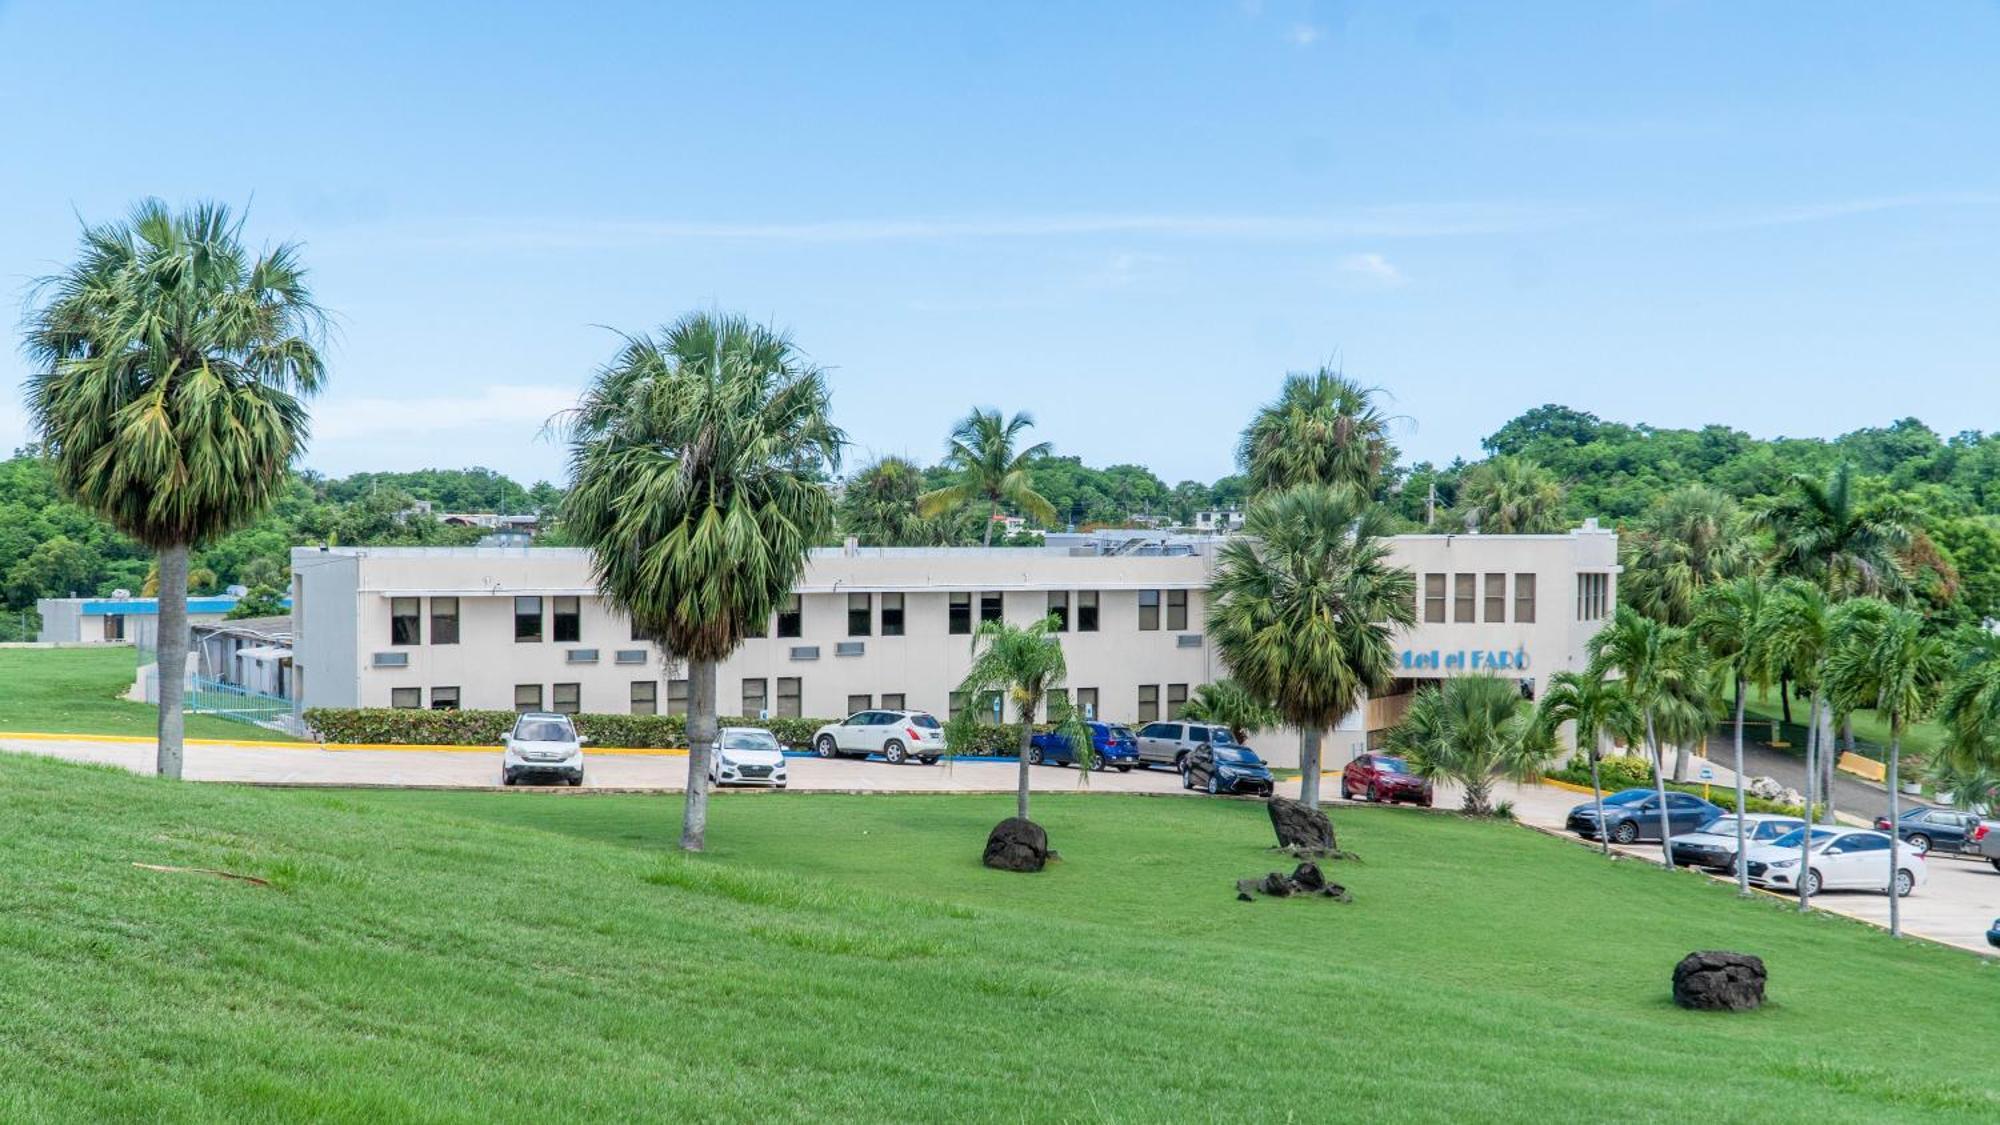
top-left (0, 0), bottom-right (2000, 482)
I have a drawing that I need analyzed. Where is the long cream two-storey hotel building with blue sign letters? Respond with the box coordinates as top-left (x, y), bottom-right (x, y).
top-left (292, 522), bottom-right (1618, 765)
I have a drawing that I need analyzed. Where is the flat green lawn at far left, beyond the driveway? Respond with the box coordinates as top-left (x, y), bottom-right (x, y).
top-left (0, 645), bottom-right (292, 741)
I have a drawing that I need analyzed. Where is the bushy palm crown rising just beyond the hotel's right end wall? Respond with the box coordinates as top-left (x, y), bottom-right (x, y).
top-left (1618, 484), bottom-right (1750, 625)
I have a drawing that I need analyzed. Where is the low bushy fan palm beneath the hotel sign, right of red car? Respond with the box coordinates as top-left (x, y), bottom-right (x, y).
top-left (1388, 675), bottom-right (1558, 817)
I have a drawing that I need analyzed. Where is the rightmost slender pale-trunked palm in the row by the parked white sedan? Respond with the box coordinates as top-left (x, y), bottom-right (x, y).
top-left (1824, 605), bottom-right (1950, 937)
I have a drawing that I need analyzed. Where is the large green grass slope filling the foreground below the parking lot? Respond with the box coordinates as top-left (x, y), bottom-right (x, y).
top-left (0, 755), bottom-right (2000, 1123)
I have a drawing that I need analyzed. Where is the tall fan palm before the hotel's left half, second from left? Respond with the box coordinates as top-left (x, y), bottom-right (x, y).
top-left (560, 312), bottom-right (844, 851)
